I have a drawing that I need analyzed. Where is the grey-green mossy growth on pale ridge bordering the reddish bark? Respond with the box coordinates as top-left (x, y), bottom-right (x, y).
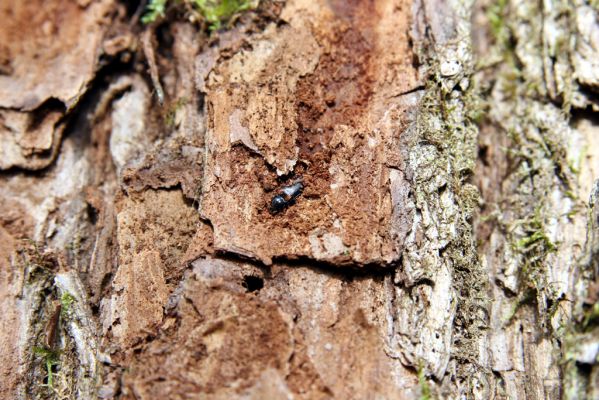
top-left (409, 36), bottom-right (489, 390)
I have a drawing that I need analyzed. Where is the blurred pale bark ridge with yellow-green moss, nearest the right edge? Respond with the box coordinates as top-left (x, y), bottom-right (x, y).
top-left (488, 1), bottom-right (596, 329)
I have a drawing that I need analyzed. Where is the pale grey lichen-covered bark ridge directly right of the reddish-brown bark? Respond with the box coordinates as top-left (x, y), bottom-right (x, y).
top-left (394, 2), bottom-right (489, 397)
